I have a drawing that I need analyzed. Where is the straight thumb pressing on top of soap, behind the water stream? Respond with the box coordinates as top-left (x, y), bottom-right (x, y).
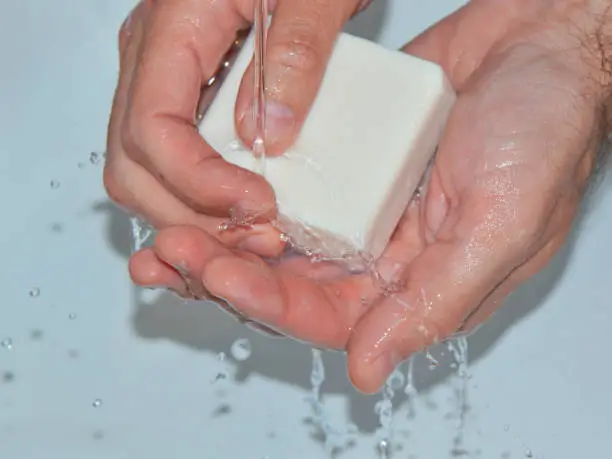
top-left (236, 0), bottom-right (359, 154)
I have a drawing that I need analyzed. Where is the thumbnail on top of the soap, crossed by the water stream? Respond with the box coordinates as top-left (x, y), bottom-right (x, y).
top-left (241, 100), bottom-right (295, 151)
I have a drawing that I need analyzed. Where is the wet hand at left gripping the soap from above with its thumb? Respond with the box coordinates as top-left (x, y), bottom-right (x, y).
top-left (104, 0), bottom-right (370, 264)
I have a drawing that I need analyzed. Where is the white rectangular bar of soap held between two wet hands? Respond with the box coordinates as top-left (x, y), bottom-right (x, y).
top-left (200, 34), bottom-right (455, 258)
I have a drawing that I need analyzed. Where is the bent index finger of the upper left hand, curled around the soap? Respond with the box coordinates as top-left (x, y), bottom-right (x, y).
top-left (122, 0), bottom-right (275, 215)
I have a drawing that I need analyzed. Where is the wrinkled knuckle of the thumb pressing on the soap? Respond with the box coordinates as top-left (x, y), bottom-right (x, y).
top-left (268, 34), bottom-right (324, 73)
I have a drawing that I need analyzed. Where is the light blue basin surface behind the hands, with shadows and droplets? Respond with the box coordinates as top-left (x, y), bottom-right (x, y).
top-left (0, 0), bottom-right (612, 459)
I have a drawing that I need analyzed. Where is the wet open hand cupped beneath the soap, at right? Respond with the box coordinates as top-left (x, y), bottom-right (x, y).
top-left (132, 0), bottom-right (612, 392)
